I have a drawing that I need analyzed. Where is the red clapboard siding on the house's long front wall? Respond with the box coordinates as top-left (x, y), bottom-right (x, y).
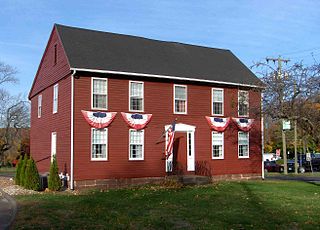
top-left (74, 77), bottom-right (261, 180)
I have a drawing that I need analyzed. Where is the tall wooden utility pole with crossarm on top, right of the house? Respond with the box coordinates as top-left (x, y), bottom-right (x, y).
top-left (266, 56), bottom-right (290, 174)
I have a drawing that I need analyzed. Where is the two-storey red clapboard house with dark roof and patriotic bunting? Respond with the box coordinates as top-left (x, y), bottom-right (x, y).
top-left (29, 25), bottom-right (263, 189)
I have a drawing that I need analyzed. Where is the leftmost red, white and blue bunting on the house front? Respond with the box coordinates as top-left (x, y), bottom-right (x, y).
top-left (81, 110), bottom-right (117, 129)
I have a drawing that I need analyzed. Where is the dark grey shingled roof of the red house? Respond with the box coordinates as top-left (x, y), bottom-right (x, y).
top-left (55, 24), bottom-right (262, 86)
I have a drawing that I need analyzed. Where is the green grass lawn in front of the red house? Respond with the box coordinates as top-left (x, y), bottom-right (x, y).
top-left (13, 181), bottom-right (320, 229)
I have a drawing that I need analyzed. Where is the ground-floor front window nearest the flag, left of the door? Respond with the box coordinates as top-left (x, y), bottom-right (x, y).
top-left (129, 129), bottom-right (144, 160)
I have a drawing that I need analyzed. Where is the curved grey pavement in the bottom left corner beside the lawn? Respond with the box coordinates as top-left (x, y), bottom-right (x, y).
top-left (0, 188), bottom-right (17, 230)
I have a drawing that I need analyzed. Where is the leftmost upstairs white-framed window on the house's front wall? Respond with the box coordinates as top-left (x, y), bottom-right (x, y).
top-left (91, 78), bottom-right (108, 109)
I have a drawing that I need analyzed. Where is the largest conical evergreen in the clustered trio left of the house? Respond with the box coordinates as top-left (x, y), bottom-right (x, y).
top-left (25, 158), bottom-right (40, 191)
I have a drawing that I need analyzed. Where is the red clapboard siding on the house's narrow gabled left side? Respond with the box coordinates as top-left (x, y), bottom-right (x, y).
top-left (30, 26), bottom-right (71, 173)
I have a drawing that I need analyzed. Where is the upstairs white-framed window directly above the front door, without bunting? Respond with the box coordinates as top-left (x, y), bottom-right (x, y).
top-left (173, 85), bottom-right (187, 114)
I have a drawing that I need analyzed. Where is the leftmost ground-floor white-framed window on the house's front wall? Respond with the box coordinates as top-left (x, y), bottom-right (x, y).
top-left (91, 128), bottom-right (108, 160)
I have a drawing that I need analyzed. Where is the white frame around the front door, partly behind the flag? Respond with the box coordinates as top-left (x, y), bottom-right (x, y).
top-left (164, 123), bottom-right (196, 172)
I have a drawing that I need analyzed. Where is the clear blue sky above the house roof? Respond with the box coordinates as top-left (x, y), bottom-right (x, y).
top-left (0, 0), bottom-right (320, 96)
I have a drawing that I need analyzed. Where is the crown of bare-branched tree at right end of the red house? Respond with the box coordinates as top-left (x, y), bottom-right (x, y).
top-left (253, 62), bottom-right (320, 148)
